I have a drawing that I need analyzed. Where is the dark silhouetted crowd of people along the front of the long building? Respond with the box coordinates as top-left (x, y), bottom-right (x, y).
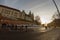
top-left (1, 23), bottom-right (27, 31)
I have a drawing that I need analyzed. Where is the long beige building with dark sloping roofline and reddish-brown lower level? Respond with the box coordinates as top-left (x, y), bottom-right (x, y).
top-left (0, 5), bottom-right (37, 29)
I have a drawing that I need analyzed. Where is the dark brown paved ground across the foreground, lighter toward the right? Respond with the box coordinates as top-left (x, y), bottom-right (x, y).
top-left (0, 28), bottom-right (60, 40)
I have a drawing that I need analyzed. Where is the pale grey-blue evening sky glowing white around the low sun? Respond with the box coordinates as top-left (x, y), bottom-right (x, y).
top-left (0, 0), bottom-right (60, 23)
